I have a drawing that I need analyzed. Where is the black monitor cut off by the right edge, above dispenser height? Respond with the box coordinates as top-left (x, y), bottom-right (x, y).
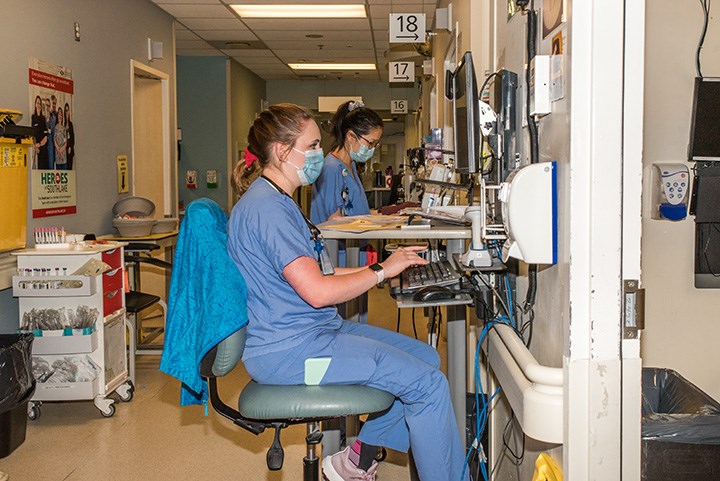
top-left (688, 77), bottom-right (720, 161)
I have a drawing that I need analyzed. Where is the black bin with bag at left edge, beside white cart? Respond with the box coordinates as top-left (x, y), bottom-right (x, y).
top-left (0, 333), bottom-right (35, 458)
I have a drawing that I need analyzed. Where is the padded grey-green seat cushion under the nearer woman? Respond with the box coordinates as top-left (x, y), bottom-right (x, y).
top-left (238, 381), bottom-right (395, 420)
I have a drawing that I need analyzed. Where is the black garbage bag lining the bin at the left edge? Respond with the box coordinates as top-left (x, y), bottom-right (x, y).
top-left (0, 333), bottom-right (35, 413)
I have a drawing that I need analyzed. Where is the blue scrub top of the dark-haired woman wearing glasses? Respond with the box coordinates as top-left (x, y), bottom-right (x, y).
top-left (310, 153), bottom-right (370, 224)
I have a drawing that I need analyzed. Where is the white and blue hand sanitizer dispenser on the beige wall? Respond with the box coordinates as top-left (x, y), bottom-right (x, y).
top-left (651, 163), bottom-right (690, 220)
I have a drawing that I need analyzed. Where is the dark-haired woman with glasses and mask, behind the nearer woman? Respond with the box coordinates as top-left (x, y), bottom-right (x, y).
top-left (310, 100), bottom-right (383, 224)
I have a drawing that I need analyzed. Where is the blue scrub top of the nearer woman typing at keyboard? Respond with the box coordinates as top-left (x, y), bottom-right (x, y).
top-left (227, 178), bottom-right (342, 359)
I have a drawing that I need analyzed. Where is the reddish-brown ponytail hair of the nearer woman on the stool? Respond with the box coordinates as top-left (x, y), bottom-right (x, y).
top-left (231, 104), bottom-right (313, 195)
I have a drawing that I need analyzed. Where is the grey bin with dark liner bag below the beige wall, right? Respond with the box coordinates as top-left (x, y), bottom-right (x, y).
top-left (641, 368), bottom-right (720, 481)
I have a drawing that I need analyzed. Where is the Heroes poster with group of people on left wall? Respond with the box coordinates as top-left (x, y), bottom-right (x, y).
top-left (28, 58), bottom-right (77, 218)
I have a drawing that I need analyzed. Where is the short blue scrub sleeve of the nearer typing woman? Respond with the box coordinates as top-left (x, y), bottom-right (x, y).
top-left (258, 198), bottom-right (315, 275)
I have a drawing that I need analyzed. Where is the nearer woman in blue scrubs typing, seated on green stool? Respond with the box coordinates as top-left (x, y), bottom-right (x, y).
top-left (228, 104), bottom-right (469, 481)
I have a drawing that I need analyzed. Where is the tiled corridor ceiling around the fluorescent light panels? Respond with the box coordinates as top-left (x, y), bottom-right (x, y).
top-left (152, 0), bottom-right (437, 81)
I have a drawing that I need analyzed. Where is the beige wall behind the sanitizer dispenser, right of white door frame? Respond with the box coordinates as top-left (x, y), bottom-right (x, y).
top-left (642, 0), bottom-right (720, 399)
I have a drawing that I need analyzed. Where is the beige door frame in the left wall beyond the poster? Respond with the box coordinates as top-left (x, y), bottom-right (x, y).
top-left (130, 59), bottom-right (175, 217)
